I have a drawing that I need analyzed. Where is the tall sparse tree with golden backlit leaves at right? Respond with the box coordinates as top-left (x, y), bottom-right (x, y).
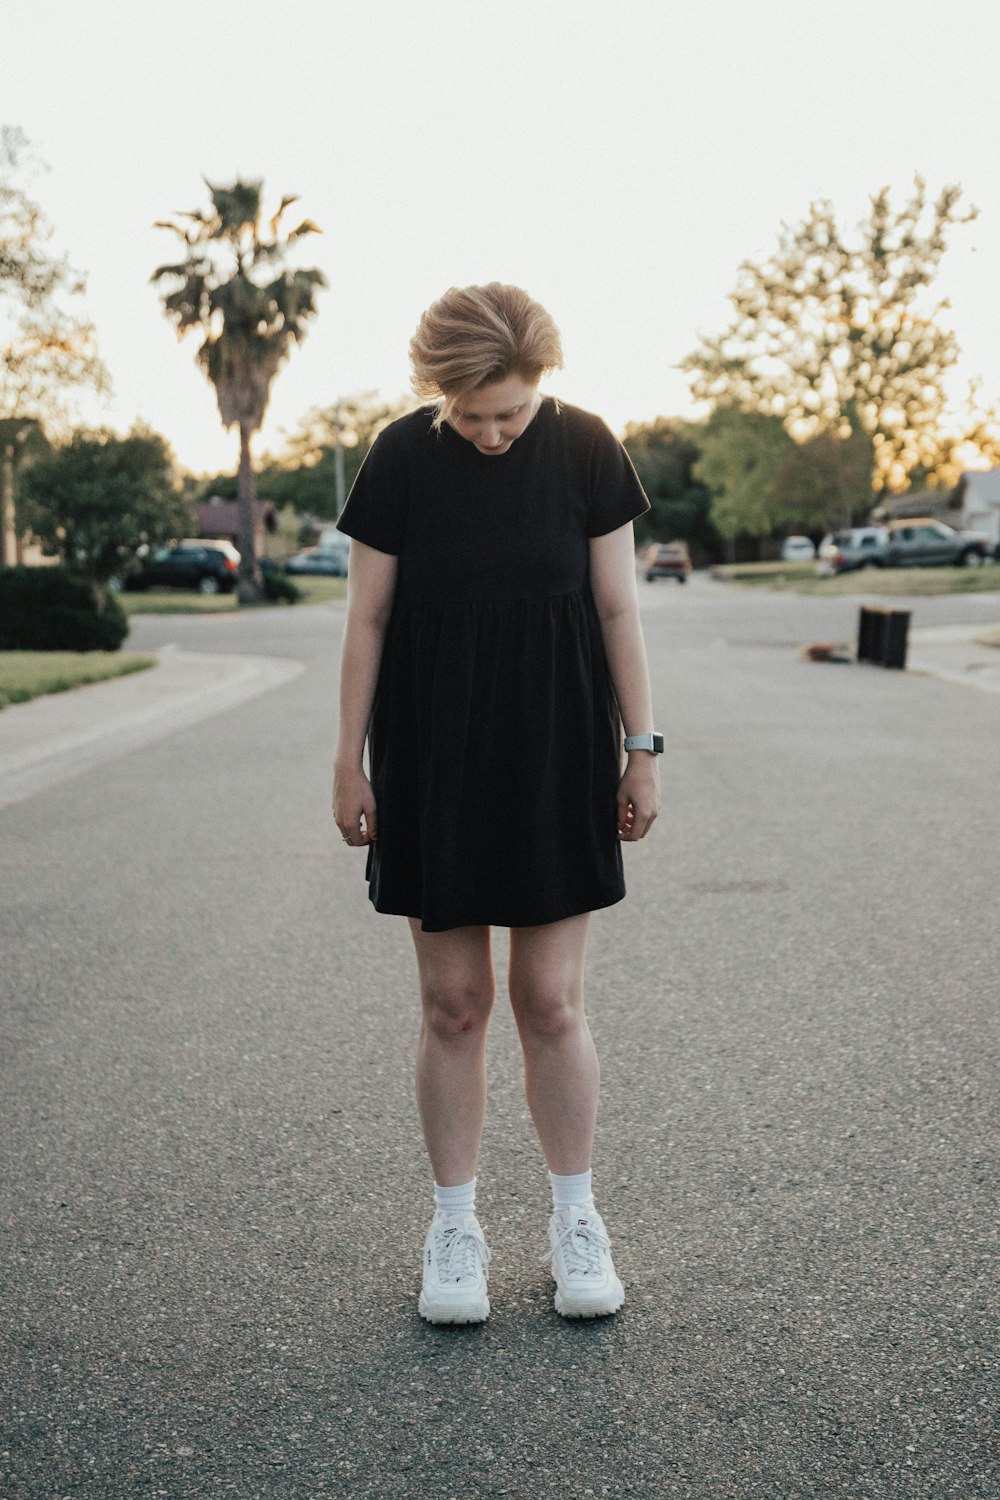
top-left (684, 177), bottom-right (975, 489)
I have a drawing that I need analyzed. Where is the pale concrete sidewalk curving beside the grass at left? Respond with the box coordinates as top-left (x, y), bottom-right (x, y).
top-left (0, 647), bottom-right (304, 807)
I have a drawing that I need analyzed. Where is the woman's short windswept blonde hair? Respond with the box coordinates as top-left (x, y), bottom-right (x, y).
top-left (409, 282), bottom-right (562, 420)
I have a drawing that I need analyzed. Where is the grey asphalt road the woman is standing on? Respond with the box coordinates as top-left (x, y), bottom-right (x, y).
top-left (0, 579), bottom-right (1000, 1500)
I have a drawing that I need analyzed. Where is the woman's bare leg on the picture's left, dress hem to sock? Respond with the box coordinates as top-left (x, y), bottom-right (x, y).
top-left (409, 920), bottom-right (495, 1188)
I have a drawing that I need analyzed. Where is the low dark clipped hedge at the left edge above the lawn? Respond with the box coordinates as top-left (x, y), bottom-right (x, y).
top-left (0, 567), bottom-right (129, 651)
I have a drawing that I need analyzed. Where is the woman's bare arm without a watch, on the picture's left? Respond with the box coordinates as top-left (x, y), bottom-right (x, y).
top-left (333, 542), bottom-right (397, 848)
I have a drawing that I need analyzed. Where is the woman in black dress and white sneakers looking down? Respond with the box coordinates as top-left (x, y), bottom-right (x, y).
top-left (333, 282), bottom-right (663, 1323)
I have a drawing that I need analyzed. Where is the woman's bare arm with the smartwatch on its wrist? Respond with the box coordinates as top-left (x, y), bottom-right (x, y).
top-left (591, 522), bottom-right (660, 840)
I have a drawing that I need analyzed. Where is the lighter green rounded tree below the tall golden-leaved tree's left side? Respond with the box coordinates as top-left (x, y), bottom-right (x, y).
top-left (694, 407), bottom-right (795, 555)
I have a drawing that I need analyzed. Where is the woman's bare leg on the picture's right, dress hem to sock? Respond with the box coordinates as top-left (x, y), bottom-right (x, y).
top-left (510, 914), bottom-right (601, 1175)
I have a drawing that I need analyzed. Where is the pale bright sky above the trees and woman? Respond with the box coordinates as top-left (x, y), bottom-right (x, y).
top-left (0, 0), bottom-right (1000, 473)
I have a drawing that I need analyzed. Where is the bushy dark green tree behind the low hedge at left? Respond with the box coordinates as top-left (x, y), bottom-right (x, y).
top-left (21, 428), bottom-right (190, 603)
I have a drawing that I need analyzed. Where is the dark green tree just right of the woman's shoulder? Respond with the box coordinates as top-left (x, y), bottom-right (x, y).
top-left (622, 417), bottom-right (718, 555)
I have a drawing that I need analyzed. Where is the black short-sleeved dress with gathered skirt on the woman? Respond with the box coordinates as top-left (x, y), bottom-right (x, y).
top-left (339, 399), bottom-right (649, 932)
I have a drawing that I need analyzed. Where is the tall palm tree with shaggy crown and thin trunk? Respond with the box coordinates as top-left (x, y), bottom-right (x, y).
top-left (150, 179), bottom-right (327, 603)
